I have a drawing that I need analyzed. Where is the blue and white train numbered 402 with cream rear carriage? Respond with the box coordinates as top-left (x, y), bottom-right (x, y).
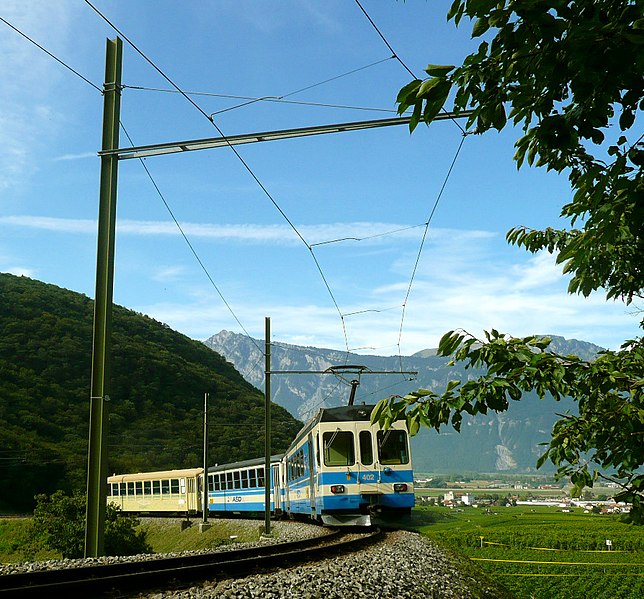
top-left (108, 405), bottom-right (414, 526)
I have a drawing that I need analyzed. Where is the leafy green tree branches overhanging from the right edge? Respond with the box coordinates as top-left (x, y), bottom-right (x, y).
top-left (372, 0), bottom-right (644, 524)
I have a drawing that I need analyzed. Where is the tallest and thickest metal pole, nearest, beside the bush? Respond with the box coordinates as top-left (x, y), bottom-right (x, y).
top-left (85, 37), bottom-right (123, 557)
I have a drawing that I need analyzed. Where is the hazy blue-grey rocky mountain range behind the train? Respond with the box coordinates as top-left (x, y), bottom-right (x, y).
top-left (205, 331), bottom-right (602, 473)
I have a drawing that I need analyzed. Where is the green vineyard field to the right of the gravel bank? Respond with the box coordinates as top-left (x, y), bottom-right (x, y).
top-left (413, 506), bottom-right (644, 599)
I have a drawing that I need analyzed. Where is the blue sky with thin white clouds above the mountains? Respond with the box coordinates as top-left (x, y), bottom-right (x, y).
top-left (0, 0), bottom-right (638, 355)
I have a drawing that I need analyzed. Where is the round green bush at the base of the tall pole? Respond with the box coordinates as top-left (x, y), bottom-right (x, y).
top-left (33, 491), bottom-right (152, 558)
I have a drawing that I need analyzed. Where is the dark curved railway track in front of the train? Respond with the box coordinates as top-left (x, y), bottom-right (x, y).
top-left (0, 529), bottom-right (384, 599)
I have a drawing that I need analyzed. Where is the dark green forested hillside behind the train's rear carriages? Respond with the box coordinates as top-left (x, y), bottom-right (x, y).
top-left (0, 273), bottom-right (301, 510)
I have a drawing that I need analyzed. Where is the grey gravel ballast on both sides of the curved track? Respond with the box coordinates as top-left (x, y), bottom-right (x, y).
top-left (0, 520), bottom-right (498, 599)
